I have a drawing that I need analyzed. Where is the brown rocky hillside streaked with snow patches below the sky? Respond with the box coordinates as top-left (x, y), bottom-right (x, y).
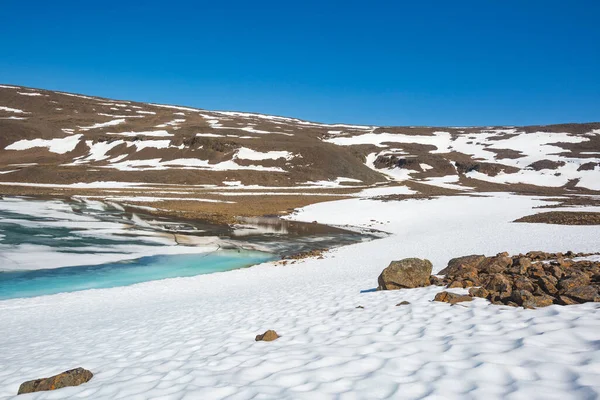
top-left (0, 85), bottom-right (600, 193)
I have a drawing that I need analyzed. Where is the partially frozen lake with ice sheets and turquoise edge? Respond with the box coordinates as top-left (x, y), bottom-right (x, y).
top-left (0, 197), bottom-right (365, 300)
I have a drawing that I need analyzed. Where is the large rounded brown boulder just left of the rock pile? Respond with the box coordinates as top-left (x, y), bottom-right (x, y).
top-left (377, 258), bottom-right (433, 290)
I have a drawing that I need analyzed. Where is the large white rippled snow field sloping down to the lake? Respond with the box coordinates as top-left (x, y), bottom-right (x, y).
top-left (0, 194), bottom-right (600, 399)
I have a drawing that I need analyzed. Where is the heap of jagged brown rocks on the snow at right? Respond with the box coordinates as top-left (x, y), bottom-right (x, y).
top-left (430, 251), bottom-right (600, 308)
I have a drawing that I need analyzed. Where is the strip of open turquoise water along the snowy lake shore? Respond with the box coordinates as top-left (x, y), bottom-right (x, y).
top-left (0, 250), bottom-right (277, 300)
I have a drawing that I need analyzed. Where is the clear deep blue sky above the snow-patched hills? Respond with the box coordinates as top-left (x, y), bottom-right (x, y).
top-left (0, 0), bottom-right (600, 125)
